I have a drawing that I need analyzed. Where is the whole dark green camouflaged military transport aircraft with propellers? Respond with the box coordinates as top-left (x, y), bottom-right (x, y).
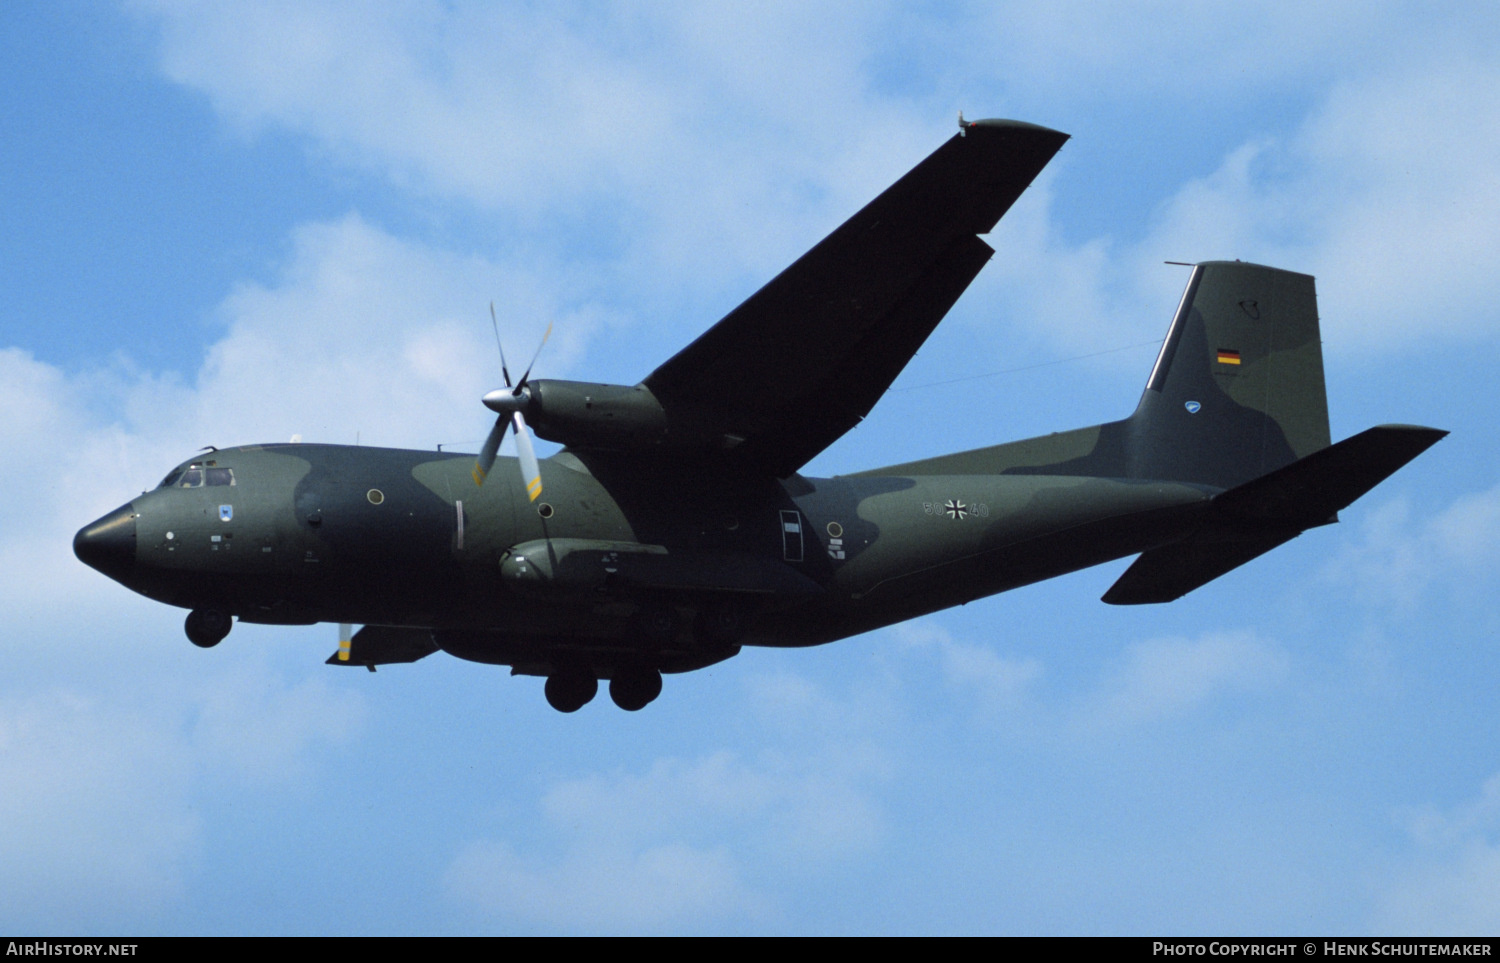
top-left (74, 114), bottom-right (1446, 713)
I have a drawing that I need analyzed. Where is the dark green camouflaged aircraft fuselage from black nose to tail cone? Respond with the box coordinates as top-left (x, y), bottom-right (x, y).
top-left (78, 444), bottom-right (1217, 678)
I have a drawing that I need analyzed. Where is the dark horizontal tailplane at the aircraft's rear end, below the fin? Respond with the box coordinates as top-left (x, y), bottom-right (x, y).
top-left (1104, 425), bottom-right (1448, 605)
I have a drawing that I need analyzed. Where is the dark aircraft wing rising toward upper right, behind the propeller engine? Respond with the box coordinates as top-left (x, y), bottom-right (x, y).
top-left (645, 120), bottom-right (1068, 477)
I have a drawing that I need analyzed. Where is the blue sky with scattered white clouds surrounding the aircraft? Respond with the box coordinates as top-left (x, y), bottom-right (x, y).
top-left (0, 2), bottom-right (1500, 935)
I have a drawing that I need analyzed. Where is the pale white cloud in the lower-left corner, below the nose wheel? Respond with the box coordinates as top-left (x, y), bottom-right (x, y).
top-left (0, 663), bottom-right (366, 932)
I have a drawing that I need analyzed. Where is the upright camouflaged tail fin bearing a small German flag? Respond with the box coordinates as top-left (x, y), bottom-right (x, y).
top-left (1125, 261), bottom-right (1329, 489)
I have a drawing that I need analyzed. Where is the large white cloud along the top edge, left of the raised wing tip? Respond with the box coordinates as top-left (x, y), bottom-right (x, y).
top-left (138, 2), bottom-right (926, 294)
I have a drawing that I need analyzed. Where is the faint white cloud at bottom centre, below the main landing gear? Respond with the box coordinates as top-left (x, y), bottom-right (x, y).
top-left (446, 675), bottom-right (891, 932)
